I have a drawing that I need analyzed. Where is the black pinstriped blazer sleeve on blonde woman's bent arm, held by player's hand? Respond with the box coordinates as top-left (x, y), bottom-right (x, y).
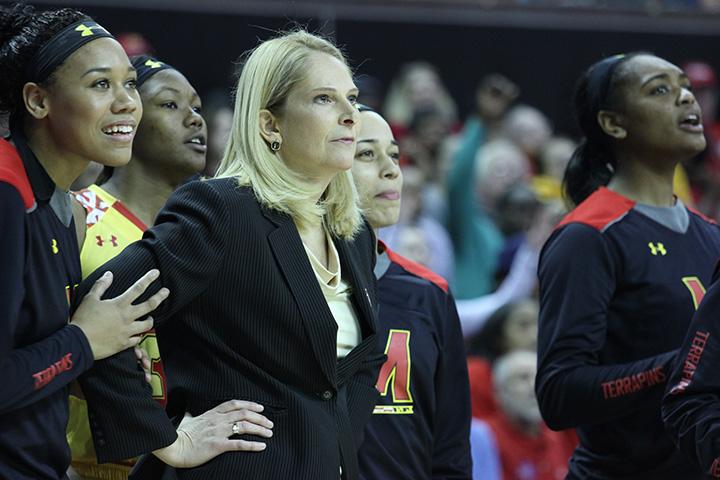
top-left (79, 182), bottom-right (228, 461)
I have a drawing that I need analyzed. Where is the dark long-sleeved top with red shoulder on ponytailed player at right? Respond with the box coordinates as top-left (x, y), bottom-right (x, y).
top-left (536, 188), bottom-right (720, 480)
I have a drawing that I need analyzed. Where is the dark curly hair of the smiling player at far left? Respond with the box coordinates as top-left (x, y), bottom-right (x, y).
top-left (0, 3), bottom-right (87, 117)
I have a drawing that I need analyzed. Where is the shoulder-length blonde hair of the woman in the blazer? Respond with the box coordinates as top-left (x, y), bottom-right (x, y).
top-left (215, 30), bottom-right (362, 239)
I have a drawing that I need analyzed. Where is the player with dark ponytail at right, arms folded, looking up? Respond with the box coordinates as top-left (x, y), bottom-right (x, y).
top-left (536, 53), bottom-right (720, 480)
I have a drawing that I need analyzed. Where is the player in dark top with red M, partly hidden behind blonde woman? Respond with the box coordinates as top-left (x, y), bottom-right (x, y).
top-left (352, 107), bottom-right (472, 480)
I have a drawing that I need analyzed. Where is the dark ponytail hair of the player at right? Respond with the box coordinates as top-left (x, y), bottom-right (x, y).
top-left (563, 52), bottom-right (650, 205)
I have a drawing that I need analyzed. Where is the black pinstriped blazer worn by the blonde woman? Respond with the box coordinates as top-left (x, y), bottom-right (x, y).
top-left (76, 179), bottom-right (384, 480)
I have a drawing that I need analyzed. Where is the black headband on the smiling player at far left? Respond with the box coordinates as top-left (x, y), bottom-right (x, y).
top-left (25, 18), bottom-right (113, 83)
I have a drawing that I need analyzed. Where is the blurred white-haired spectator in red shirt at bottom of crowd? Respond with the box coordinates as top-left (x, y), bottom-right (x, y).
top-left (471, 350), bottom-right (575, 480)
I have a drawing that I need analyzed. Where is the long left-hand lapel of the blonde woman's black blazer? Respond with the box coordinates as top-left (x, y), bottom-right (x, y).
top-left (263, 209), bottom-right (337, 385)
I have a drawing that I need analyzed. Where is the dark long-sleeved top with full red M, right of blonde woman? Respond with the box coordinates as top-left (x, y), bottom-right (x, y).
top-left (358, 249), bottom-right (472, 480)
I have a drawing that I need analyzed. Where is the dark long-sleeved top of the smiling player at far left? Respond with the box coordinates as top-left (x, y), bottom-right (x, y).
top-left (0, 138), bottom-right (93, 480)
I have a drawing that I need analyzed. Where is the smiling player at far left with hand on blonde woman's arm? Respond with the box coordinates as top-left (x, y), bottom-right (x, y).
top-left (0, 5), bottom-right (173, 480)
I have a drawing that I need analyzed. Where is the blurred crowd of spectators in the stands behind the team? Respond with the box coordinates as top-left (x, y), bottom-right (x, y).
top-left (57, 31), bottom-right (720, 480)
